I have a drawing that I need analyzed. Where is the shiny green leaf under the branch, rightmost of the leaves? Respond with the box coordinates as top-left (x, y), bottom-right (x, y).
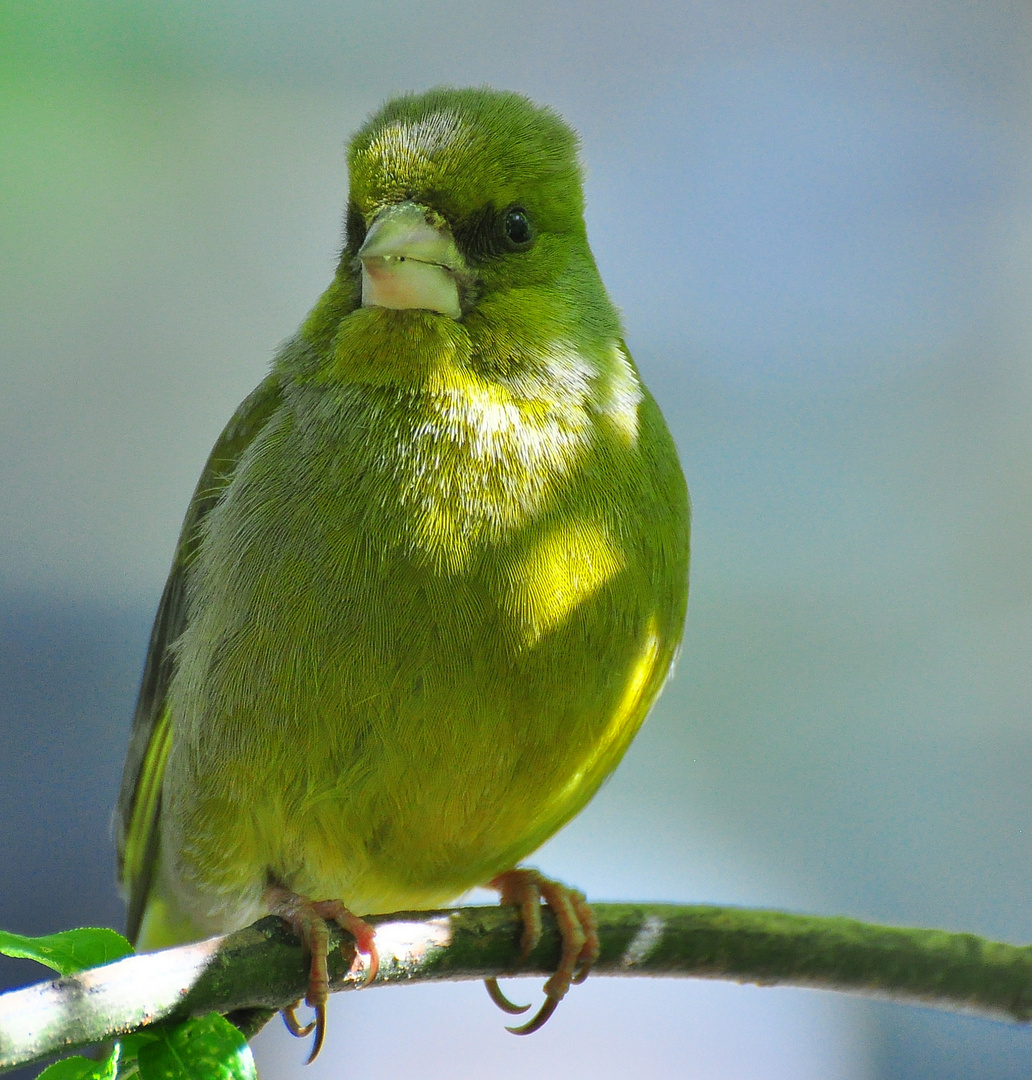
top-left (138, 1013), bottom-right (258, 1080)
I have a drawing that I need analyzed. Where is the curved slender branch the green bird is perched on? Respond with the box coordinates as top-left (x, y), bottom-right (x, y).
top-left (0, 904), bottom-right (1032, 1072)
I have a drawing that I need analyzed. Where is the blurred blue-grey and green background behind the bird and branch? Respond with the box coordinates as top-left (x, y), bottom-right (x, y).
top-left (0, 0), bottom-right (1032, 1080)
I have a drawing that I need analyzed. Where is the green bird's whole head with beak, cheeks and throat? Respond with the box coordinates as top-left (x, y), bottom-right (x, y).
top-left (293, 87), bottom-right (621, 395)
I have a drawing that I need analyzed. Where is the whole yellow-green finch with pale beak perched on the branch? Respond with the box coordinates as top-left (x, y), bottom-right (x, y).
top-left (118, 89), bottom-right (689, 1050)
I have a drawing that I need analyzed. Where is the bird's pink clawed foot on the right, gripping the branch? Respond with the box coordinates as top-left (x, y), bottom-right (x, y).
top-left (484, 867), bottom-right (599, 1035)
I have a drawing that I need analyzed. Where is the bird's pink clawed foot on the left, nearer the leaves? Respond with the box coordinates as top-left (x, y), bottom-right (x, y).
top-left (264, 886), bottom-right (380, 1064)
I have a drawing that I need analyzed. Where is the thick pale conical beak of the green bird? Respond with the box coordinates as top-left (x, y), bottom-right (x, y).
top-left (358, 202), bottom-right (465, 319)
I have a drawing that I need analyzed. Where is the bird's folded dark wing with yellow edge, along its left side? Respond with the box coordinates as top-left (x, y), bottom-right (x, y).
top-left (114, 375), bottom-right (283, 941)
